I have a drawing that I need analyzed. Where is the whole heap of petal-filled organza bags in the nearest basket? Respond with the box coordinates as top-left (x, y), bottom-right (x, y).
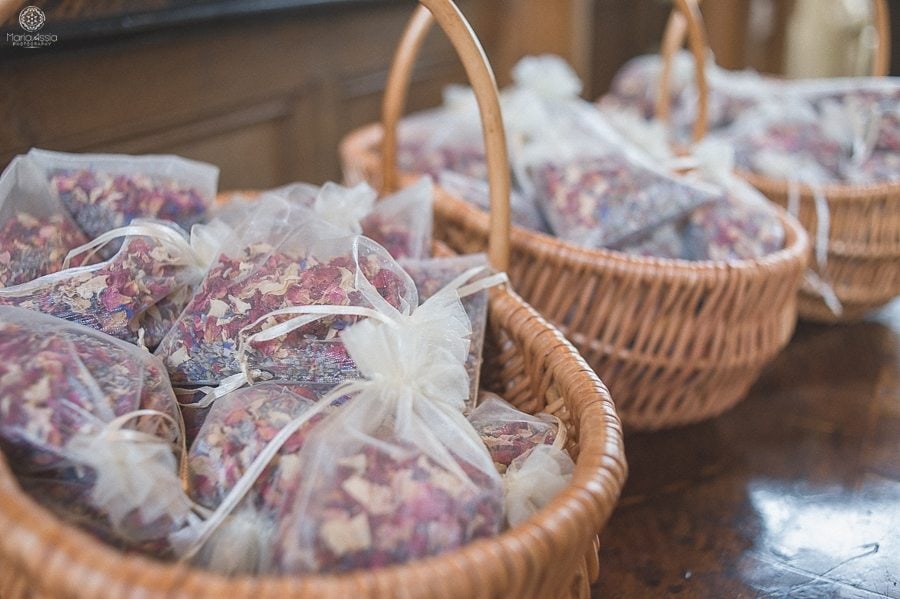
top-left (0, 150), bottom-right (574, 574)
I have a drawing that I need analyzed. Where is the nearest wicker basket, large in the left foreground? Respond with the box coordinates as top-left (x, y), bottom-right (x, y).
top-left (0, 0), bottom-right (626, 599)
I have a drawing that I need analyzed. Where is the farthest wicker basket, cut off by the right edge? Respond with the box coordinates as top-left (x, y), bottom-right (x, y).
top-left (658, 0), bottom-right (900, 322)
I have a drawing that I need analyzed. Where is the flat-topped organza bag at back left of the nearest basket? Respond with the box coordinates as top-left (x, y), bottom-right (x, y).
top-left (28, 149), bottom-right (219, 244)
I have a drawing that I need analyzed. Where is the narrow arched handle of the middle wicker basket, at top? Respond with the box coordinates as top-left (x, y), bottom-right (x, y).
top-left (656, 0), bottom-right (709, 143)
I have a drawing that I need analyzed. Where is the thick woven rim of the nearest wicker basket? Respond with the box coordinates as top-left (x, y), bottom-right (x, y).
top-left (0, 288), bottom-right (627, 596)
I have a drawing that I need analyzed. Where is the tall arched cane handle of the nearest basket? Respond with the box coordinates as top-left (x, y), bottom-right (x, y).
top-left (381, 0), bottom-right (510, 271)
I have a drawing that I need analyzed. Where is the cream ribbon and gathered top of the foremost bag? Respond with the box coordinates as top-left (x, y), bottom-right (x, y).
top-left (176, 267), bottom-right (506, 560)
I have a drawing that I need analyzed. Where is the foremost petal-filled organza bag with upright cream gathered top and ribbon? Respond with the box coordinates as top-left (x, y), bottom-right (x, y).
top-left (171, 273), bottom-right (503, 574)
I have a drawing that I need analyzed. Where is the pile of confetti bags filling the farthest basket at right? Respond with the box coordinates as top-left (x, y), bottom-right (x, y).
top-left (599, 51), bottom-right (900, 185)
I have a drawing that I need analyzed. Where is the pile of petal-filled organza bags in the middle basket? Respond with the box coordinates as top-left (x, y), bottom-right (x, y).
top-left (399, 56), bottom-right (784, 261)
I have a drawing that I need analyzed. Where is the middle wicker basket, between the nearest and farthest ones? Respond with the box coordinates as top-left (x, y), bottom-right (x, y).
top-left (341, 0), bottom-right (809, 429)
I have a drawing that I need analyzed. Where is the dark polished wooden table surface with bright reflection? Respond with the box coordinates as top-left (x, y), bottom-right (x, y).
top-left (593, 300), bottom-right (900, 598)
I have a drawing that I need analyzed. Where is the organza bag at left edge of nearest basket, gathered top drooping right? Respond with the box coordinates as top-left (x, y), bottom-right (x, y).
top-left (0, 307), bottom-right (192, 557)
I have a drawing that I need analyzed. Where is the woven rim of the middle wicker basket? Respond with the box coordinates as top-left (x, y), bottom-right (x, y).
top-left (340, 123), bottom-right (809, 278)
